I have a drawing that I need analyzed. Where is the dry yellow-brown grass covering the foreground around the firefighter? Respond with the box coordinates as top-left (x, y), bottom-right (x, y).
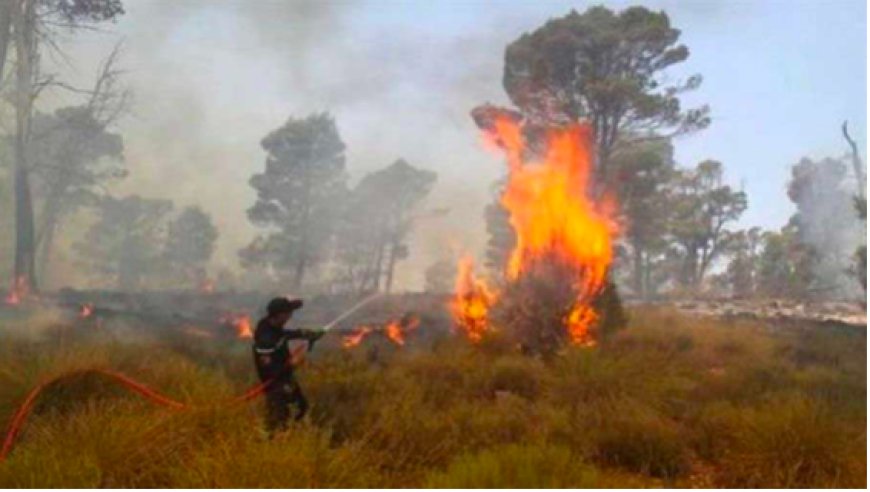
top-left (0, 310), bottom-right (867, 487)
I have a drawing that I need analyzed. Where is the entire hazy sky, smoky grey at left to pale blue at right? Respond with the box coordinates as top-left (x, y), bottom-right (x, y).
top-left (52, 0), bottom-right (867, 287)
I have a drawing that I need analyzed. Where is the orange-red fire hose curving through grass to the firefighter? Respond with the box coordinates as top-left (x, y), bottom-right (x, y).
top-left (0, 344), bottom-right (310, 463)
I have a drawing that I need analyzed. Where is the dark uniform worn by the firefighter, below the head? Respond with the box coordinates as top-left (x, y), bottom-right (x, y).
top-left (254, 317), bottom-right (318, 431)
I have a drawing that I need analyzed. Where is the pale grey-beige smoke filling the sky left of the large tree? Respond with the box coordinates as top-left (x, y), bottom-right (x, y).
top-left (42, 0), bottom-right (516, 289)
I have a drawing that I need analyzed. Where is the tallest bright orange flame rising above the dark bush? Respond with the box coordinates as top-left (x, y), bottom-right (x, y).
top-left (476, 115), bottom-right (619, 345)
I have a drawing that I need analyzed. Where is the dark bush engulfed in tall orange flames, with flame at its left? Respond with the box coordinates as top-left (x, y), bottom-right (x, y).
top-left (453, 106), bottom-right (623, 353)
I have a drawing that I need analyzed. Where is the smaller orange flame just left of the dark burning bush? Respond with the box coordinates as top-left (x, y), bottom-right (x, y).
top-left (450, 256), bottom-right (498, 342)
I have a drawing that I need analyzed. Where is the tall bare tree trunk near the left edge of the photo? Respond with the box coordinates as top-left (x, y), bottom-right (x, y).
top-left (12, 0), bottom-right (37, 291)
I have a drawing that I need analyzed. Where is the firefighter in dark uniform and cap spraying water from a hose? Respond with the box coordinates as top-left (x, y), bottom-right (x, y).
top-left (254, 297), bottom-right (324, 434)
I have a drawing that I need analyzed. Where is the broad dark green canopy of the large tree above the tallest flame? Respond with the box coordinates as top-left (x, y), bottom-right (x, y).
top-left (503, 6), bottom-right (710, 171)
